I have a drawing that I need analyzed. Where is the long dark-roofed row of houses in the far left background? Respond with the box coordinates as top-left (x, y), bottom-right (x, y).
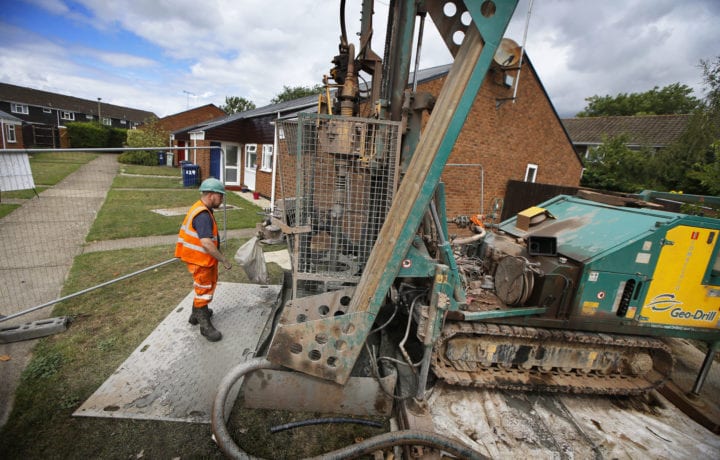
top-left (0, 83), bottom-right (155, 147)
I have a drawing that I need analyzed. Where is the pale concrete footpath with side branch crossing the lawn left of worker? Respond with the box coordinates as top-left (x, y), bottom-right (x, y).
top-left (0, 154), bottom-right (269, 427)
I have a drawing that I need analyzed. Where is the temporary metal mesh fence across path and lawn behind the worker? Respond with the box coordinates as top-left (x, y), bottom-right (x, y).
top-left (0, 149), bottom-right (227, 327)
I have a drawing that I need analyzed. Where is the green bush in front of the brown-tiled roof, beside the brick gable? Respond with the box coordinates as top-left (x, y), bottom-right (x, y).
top-left (580, 135), bottom-right (652, 192)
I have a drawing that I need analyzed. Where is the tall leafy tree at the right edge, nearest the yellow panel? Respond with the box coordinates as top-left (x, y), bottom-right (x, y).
top-left (655, 56), bottom-right (720, 195)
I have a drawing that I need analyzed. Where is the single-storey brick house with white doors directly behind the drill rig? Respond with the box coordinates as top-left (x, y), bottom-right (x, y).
top-left (174, 54), bottom-right (582, 217)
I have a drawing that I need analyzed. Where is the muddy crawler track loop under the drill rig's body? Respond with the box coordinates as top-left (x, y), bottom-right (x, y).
top-left (433, 322), bottom-right (674, 395)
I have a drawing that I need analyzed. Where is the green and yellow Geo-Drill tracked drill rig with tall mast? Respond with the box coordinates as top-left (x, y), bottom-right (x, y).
top-left (213, 0), bottom-right (720, 456)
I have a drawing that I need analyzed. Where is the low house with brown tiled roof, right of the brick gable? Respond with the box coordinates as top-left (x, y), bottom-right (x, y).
top-left (562, 114), bottom-right (690, 158)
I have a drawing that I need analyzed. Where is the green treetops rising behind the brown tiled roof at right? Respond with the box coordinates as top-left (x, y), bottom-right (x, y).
top-left (577, 83), bottom-right (700, 117)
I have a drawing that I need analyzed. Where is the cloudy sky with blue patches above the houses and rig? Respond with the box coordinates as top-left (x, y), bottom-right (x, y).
top-left (0, 0), bottom-right (720, 117)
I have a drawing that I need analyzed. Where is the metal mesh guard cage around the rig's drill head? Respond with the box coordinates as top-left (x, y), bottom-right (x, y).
top-left (279, 114), bottom-right (400, 296)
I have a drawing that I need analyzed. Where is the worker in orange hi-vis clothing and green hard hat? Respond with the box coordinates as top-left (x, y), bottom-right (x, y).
top-left (175, 178), bottom-right (232, 342)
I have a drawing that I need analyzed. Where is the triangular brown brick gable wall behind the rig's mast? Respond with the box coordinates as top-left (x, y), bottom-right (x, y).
top-left (436, 63), bottom-right (582, 221)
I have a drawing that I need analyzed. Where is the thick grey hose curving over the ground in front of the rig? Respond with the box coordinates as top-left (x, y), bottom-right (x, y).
top-left (212, 358), bottom-right (485, 460)
